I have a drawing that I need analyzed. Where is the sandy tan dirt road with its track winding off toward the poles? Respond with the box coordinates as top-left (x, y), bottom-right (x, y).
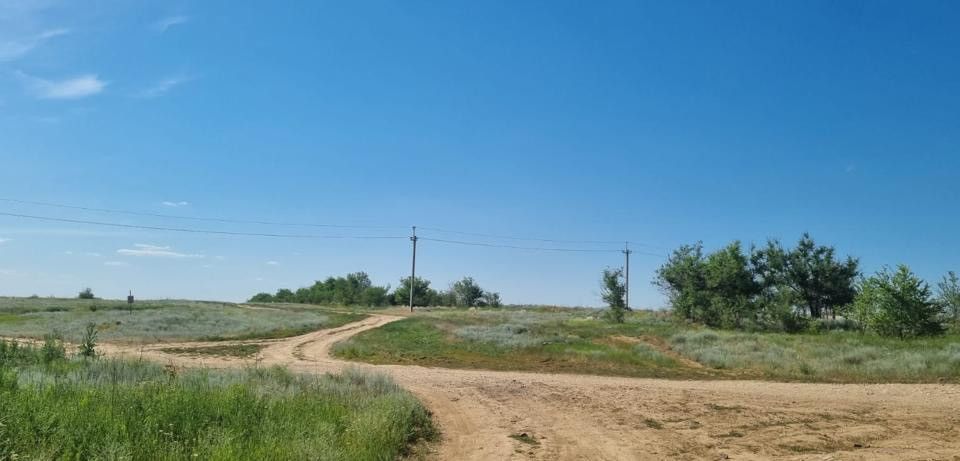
top-left (103, 315), bottom-right (960, 460)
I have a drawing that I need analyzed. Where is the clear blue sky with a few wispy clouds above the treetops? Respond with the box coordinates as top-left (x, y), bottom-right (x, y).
top-left (0, 0), bottom-right (960, 307)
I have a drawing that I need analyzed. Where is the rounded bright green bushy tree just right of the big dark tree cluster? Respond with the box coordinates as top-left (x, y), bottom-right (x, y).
top-left (854, 264), bottom-right (943, 339)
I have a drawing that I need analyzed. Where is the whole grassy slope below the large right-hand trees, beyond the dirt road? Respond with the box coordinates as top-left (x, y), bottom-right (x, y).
top-left (334, 309), bottom-right (960, 382)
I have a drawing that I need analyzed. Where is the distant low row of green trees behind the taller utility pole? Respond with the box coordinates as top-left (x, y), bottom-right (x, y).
top-left (250, 272), bottom-right (501, 307)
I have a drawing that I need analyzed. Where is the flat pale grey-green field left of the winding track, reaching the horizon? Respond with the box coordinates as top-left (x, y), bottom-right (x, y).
top-left (0, 298), bottom-right (364, 342)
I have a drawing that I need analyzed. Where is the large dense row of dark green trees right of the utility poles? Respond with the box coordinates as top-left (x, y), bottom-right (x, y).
top-left (654, 234), bottom-right (960, 338)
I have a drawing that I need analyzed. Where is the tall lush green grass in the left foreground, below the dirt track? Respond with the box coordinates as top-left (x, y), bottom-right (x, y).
top-left (0, 336), bottom-right (435, 460)
